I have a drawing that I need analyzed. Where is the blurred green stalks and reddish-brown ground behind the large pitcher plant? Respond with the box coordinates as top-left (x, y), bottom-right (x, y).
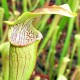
top-left (0, 0), bottom-right (80, 80)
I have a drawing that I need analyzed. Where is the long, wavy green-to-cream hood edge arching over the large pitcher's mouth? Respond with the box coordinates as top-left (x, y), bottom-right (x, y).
top-left (4, 4), bottom-right (77, 25)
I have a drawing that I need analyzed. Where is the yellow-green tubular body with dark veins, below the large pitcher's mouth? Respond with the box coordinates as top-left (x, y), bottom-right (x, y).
top-left (9, 41), bottom-right (39, 80)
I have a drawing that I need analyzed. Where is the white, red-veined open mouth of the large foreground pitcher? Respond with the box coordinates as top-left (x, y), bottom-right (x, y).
top-left (8, 19), bottom-right (43, 46)
